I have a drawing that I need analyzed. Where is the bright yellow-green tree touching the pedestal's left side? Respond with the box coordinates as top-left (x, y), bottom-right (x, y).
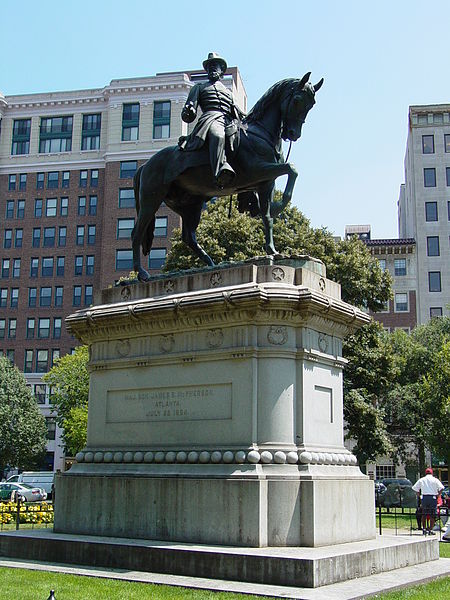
top-left (43, 346), bottom-right (89, 456)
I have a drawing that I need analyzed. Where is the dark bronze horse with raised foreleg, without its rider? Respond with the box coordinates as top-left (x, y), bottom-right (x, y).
top-left (131, 73), bottom-right (323, 281)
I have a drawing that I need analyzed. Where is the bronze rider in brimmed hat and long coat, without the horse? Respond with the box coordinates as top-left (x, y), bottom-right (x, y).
top-left (180, 52), bottom-right (244, 188)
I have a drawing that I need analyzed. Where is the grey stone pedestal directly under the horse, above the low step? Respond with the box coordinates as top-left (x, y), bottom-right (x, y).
top-left (55, 257), bottom-right (375, 547)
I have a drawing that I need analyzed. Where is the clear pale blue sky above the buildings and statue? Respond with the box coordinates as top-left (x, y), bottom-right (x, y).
top-left (0, 0), bottom-right (450, 238)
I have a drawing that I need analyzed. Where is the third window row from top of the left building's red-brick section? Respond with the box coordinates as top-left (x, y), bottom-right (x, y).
top-left (3, 225), bottom-right (97, 249)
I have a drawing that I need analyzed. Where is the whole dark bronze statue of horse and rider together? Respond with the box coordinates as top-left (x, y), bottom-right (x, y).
top-left (131, 52), bottom-right (323, 281)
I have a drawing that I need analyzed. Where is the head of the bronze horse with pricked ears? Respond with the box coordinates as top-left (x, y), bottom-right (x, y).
top-left (281, 73), bottom-right (323, 142)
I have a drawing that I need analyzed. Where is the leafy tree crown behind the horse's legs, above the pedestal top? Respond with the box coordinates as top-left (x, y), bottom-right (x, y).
top-left (164, 197), bottom-right (391, 311)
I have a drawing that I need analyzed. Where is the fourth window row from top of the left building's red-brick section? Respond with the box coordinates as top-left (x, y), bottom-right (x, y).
top-left (0, 255), bottom-right (95, 279)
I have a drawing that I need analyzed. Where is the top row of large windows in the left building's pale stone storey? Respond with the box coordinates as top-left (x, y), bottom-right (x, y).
top-left (11, 101), bottom-right (171, 155)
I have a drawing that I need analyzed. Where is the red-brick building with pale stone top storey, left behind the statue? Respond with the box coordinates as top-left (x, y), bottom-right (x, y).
top-left (0, 67), bottom-right (247, 468)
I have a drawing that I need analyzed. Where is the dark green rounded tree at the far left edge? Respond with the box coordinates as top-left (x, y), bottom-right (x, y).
top-left (0, 356), bottom-right (47, 473)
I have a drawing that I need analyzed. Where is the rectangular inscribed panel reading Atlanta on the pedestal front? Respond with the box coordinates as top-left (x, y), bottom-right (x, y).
top-left (106, 383), bottom-right (232, 423)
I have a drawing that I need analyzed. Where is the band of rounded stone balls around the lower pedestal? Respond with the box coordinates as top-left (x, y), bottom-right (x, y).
top-left (75, 448), bottom-right (358, 467)
